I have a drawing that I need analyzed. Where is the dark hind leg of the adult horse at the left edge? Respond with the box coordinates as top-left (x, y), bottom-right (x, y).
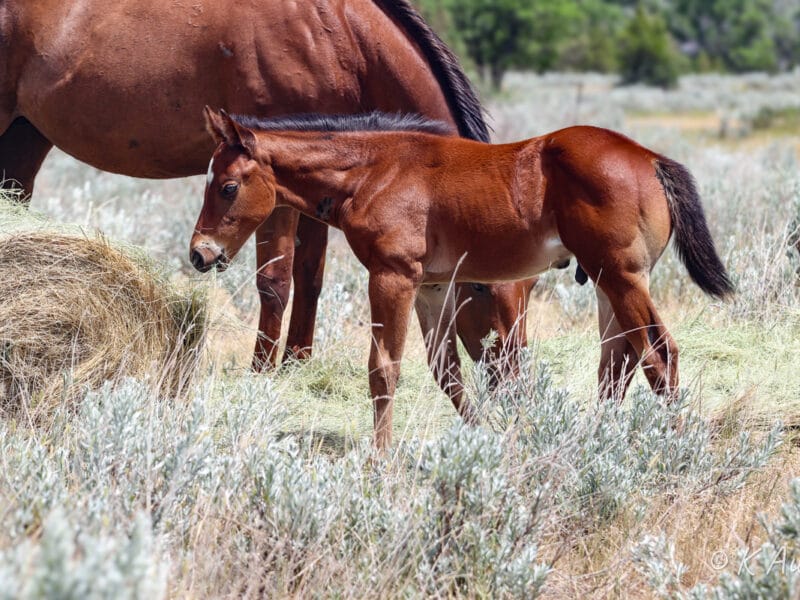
top-left (0, 117), bottom-right (53, 201)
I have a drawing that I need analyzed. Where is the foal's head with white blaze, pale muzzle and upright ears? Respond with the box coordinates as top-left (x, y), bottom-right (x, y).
top-left (189, 107), bottom-right (275, 271)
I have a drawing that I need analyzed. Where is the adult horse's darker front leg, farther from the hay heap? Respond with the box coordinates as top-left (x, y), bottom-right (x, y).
top-left (284, 215), bottom-right (328, 359)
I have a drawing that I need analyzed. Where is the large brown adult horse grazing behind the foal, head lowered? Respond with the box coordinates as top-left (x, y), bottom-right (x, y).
top-left (0, 0), bottom-right (531, 369)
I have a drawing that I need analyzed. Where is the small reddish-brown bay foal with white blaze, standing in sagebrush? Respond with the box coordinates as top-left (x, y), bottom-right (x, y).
top-left (191, 108), bottom-right (733, 448)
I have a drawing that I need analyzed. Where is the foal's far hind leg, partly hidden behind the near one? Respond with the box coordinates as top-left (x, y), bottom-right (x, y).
top-left (595, 287), bottom-right (639, 400)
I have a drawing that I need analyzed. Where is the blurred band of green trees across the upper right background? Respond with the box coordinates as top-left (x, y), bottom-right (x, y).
top-left (418, 0), bottom-right (800, 89)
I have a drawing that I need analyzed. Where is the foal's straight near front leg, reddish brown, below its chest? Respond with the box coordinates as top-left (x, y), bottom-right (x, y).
top-left (369, 268), bottom-right (422, 450)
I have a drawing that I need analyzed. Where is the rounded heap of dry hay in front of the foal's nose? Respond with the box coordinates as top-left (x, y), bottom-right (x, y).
top-left (0, 231), bottom-right (206, 421)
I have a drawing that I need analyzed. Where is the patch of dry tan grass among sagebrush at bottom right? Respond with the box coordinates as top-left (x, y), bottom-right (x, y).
top-left (542, 444), bottom-right (800, 598)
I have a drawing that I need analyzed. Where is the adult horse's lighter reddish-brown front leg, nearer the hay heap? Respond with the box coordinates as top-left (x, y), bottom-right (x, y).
top-left (253, 206), bottom-right (299, 371)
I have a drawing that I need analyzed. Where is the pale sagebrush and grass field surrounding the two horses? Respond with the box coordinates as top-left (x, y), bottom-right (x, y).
top-left (0, 73), bottom-right (800, 598)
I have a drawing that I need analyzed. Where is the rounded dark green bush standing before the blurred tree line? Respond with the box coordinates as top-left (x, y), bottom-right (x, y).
top-left (620, 4), bottom-right (680, 88)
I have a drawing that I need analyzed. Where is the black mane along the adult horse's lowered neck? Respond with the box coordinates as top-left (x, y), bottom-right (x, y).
top-left (375, 0), bottom-right (489, 142)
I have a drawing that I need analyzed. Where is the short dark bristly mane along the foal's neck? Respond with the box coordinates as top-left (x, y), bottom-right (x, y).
top-left (232, 111), bottom-right (453, 135)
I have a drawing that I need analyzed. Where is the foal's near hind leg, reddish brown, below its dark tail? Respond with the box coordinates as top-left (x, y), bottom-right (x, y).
top-left (597, 271), bottom-right (678, 399)
